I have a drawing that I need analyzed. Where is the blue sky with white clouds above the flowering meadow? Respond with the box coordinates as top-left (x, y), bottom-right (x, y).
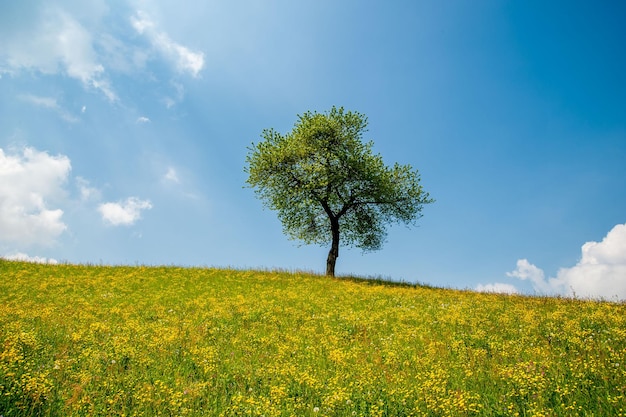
top-left (0, 0), bottom-right (626, 299)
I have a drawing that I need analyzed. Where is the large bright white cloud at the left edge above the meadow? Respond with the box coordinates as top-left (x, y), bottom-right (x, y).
top-left (0, 148), bottom-right (71, 246)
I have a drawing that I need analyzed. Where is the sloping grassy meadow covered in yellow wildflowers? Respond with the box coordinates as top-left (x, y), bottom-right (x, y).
top-left (0, 260), bottom-right (626, 417)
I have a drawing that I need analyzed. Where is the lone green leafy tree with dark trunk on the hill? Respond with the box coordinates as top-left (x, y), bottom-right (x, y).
top-left (245, 107), bottom-right (434, 276)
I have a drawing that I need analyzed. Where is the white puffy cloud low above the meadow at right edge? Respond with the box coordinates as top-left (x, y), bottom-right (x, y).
top-left (507, 224), bottom-right (626, 300)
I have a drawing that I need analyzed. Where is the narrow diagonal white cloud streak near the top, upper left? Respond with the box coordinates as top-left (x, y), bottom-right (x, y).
top-left (131, 11), bottom-right (204, 77)
